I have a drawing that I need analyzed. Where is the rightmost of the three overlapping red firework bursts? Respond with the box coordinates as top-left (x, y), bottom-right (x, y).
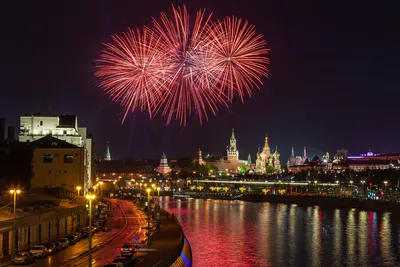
top-left (209, 17), bottom-right (269, 102)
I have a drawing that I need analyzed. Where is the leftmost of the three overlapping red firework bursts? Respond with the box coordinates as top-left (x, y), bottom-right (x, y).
top-left (95, 29), bottom-right (168, 119)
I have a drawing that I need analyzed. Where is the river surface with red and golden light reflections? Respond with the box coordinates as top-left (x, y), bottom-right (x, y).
top-left (161, 197), bottom-right (400, 267)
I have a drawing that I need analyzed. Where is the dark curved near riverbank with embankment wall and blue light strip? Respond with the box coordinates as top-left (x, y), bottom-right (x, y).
top-left (140, 210), bottom-right (192, 267)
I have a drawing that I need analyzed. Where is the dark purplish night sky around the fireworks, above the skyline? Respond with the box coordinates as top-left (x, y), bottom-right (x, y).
top-left (0, 0), bottom-right (400, 162)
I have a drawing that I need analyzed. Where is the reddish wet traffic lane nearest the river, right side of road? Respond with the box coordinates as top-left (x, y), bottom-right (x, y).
top-left (64, 201), bottom-right (147, 267)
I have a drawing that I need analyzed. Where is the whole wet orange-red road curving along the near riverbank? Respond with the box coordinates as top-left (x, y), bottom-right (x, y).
top-left (14, 199), bottom-right (147, 267)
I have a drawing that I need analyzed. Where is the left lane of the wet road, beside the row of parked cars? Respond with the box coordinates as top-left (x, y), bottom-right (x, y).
top-left (23, 201), bottom-right (122, 267)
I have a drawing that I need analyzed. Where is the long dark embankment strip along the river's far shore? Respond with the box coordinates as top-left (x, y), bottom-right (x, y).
top-left (174, 192), bottom-right (400, 214)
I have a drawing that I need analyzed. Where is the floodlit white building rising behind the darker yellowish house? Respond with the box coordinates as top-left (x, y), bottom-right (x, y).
top-left (18, 114), bottom-right (94, 193)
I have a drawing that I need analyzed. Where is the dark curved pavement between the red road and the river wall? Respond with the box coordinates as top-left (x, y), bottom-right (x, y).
top-left (137, 211), bottom-right (182, 266)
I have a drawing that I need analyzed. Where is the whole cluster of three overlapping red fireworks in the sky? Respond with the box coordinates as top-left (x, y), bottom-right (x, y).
top-left (95, 6), bottom-right (269, 124)
